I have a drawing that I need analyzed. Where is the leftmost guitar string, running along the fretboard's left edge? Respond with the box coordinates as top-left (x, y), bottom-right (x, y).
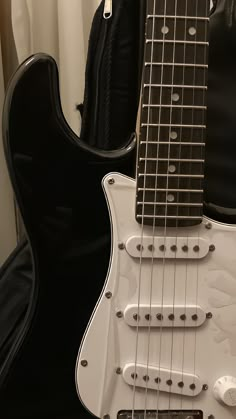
top-left (132, 0), bottom-right (156, 419)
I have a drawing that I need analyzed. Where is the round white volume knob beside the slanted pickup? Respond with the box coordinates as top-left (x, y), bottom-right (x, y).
top-left (213, 376), bottom-right (236, 407)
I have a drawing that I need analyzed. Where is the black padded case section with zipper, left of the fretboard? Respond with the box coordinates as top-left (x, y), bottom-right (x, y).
top-left (81, 0), bottom-right (145, 150)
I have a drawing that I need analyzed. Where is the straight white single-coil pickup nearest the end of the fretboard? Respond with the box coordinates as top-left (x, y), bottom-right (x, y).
top-left (126, 236), bottom-right (210, 259)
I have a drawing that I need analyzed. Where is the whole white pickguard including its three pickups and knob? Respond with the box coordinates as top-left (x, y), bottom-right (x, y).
top-left (76, 173), bottom-right (236, 419)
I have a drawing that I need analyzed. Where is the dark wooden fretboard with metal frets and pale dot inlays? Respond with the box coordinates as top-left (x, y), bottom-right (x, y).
top-left (136, 0), bottom-right (209, 227)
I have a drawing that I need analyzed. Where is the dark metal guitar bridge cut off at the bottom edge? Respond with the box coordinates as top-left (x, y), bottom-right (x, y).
top-left (117, 410), bottom-right (203, 419)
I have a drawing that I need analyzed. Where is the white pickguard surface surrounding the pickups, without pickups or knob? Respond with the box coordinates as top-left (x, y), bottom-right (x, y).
top-left (76, 173), bottom-right (236, 419)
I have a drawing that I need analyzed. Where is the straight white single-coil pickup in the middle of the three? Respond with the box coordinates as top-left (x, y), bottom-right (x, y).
top-left (124, 304), bottom-right (207, 328)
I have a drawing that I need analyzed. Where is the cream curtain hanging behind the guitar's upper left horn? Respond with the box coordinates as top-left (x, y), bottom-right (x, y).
top-left (12, 0), bottom-right (100, 134)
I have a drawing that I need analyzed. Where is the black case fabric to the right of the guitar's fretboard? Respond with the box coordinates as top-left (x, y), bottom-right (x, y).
top-left (204, 0), bottom-right (236, 223)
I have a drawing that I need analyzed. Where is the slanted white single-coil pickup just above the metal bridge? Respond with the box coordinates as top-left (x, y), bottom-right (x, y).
top-left (123, 363), bottom-right (203, 397)
